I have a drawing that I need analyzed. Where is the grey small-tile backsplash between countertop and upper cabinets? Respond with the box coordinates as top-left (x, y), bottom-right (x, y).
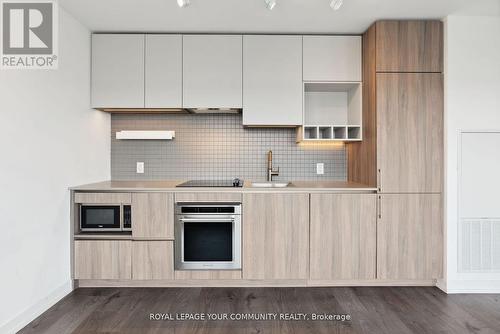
top-left (111, 114), bottom-right (347, 181)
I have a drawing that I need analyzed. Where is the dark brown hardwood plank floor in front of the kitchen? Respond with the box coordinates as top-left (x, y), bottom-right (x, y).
top-left (20, 287), bottom-right (500, 334)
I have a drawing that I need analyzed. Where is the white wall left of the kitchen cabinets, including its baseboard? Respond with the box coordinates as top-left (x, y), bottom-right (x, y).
top-left (0, 9), bottom-right (110, 333)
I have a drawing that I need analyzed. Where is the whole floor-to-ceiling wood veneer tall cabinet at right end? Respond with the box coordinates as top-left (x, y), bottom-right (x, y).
top-left (348, 21), bottom-right (444, 280)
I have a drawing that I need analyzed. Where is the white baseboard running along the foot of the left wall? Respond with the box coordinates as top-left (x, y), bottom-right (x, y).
top-left (0, 281), bottom-right (73, 333)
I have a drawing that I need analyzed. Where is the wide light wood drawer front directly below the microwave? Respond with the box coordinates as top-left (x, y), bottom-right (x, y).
top-left (75, 240), bottom-right (132, 279)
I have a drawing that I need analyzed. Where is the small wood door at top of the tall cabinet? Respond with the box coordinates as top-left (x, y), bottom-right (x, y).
top-left (376, 21), bottom-right (443, 72)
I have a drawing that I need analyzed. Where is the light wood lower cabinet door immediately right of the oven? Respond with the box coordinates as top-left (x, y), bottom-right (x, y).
top-left (242, 193), bottom-right (309, 280)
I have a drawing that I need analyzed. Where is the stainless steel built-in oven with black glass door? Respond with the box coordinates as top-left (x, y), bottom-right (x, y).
top-left (174, 203), bottom-right (241, 270)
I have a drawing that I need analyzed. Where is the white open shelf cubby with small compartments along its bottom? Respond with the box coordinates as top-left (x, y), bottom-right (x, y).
top-left (297, 82), bottom-right (362, 141)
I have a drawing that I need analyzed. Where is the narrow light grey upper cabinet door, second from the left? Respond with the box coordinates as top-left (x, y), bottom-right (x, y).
top-left (144, 35), bottom-right (182, 108)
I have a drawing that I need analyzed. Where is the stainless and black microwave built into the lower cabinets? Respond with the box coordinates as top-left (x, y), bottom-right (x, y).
top-left (80, 204), bottom-right (132, 232)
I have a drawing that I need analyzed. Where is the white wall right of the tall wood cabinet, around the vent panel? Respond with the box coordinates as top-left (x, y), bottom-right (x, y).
top-left (444, 16), bottom-right (500, 292)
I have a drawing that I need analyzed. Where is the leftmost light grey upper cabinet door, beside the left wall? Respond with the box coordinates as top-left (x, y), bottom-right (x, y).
top-left (92, 34), bottom-right (144, 108)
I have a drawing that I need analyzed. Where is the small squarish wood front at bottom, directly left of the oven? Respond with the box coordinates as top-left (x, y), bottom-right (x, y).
top-left (132, 241), bottom-right (174, 280)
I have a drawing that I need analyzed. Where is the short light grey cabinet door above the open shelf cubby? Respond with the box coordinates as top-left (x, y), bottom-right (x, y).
top-left (304, 36), bottom-right (362, 81)
